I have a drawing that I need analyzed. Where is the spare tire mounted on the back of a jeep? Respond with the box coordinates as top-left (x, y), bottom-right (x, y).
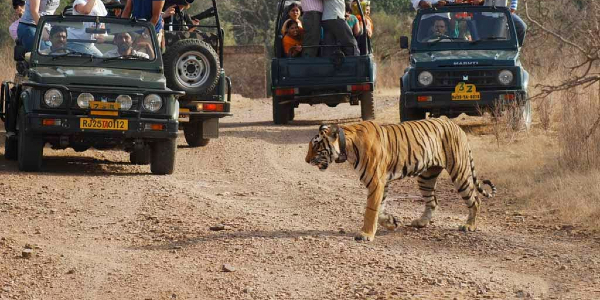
top-left (163, 39), bottom-right (219, 100)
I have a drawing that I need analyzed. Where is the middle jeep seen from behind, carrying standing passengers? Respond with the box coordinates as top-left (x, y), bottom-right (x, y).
top-left (271, 0), bottom-right (375, 124)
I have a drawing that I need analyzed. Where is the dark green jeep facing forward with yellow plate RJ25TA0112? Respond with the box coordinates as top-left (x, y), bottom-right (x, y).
top-left (0, 16), bottom-right (183, 174)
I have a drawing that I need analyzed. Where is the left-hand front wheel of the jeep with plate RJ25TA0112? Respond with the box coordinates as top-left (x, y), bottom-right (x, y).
top-left (17, 108), bottom-right (44, 172)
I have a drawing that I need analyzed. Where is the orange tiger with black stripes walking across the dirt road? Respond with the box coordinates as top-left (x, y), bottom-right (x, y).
top-left (305, 118), bottom-right (496, 241)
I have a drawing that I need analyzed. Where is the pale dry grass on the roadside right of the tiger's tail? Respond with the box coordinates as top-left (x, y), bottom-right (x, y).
top-left (471, 81), bottom-right (600, 229)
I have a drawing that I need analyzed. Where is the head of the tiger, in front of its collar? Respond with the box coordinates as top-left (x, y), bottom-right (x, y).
top-left (305, 125), bottom-right (341, 171)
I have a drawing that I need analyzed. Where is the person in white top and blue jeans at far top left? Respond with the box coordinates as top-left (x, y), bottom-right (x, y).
top-left (17, 0), bottom-right (60, 51)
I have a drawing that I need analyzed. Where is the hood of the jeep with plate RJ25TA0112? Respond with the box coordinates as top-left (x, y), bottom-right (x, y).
top-left (30, 66), bottom-right (166, 90)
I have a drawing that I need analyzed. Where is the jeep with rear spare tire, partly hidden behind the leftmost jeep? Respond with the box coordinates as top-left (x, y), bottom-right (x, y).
top-left (163, 0), bottom-right (231, 147)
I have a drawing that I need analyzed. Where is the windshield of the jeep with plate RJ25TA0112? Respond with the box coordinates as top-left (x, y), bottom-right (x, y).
top-left (36, 16), bottom-right (157, 64)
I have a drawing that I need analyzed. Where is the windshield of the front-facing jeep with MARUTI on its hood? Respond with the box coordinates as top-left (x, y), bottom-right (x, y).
top-left (413, 6), bottom-right (516, 51)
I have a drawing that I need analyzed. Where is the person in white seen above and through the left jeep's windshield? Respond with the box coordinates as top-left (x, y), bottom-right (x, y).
top-left (67, 0), bottom-right (108, 57)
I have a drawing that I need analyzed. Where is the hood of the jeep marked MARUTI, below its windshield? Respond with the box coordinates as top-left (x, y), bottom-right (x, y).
top-left (411, 50), bottom-right (519, 67)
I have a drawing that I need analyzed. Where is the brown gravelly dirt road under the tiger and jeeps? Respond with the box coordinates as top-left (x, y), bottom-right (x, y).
top-left (0, 95), bottom-right (600, 299)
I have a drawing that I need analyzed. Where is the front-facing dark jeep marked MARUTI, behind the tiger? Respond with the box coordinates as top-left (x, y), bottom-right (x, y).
top-left (400, 4), bottom-right (531, 127)
